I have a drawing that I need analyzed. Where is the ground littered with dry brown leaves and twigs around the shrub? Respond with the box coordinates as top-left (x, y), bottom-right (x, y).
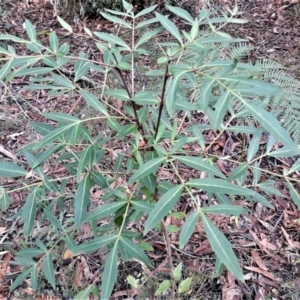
top-left (0, 0), bottom-right (300, 300)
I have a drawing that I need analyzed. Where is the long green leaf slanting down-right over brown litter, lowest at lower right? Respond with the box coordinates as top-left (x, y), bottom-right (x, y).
top-left (201, 213), bottom-right (244, 282)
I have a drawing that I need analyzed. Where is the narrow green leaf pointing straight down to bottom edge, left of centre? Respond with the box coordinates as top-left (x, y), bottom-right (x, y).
top-left (101, 243), bottom-right (118, 299)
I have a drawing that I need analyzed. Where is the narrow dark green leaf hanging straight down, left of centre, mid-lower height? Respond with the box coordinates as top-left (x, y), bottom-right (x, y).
top-left (74, 176), bottom-right (90, 229)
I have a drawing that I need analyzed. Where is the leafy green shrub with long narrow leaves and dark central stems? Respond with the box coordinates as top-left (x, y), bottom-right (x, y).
top-left (0, 1), bottom-right (300, 299)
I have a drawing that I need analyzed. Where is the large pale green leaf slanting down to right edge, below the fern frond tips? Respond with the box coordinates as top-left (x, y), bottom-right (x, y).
top-left (244, 102), bottom-right (300, 154)
